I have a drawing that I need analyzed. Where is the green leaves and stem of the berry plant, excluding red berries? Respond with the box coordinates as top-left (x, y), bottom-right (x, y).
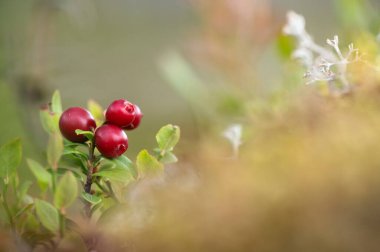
top-left (0, 91), bottom-right (180, 246)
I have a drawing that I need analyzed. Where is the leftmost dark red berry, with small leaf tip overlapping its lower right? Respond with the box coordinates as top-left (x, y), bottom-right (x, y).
top-left (59, 107), bottom-right (96, 143)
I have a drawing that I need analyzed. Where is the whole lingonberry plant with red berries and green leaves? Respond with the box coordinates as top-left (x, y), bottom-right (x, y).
top-left (0, 91), bottom-right (180, 249)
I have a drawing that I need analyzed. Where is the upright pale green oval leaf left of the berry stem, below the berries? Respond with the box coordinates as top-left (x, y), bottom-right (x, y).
top-left (54, 172), bottom-right (78, 209)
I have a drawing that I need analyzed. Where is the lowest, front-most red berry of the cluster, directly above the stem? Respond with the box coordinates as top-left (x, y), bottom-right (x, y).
top-left (95, 124), bottom-right (128, 158)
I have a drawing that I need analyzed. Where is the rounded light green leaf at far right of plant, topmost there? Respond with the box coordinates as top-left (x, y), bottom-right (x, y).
top-left (156, 124), bottom-right (180, 151)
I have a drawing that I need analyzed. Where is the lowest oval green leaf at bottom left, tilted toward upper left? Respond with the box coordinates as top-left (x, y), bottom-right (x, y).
top-left (34, 199), bottom-right (59, 233)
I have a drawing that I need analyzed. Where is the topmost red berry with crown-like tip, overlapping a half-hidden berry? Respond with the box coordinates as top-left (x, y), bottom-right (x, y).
top-left (106, 99), bottom-right (136, 128)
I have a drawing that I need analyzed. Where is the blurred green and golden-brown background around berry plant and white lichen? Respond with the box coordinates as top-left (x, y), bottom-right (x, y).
top-left (0, 0), bottom-right (380, 252)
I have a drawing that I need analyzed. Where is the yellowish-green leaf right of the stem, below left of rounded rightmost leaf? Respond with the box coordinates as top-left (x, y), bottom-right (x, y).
top-left (136, 150), bottom-right (164, 178)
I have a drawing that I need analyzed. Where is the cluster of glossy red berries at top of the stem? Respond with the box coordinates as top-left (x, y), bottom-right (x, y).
top-left (59, 99), bottom-right (143, 158)
